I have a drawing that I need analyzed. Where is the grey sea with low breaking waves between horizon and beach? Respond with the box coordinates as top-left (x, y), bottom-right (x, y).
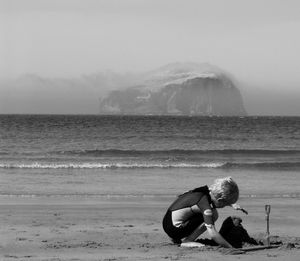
top-left (0, 115), bottom-right (300, 200)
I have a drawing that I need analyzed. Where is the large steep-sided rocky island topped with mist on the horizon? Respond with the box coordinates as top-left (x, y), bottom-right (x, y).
top-left (100, 63), bottom-right (247, 116)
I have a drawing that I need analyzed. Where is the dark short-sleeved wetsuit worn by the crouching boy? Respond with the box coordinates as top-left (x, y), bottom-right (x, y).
top-left (163, 186), bottom-right (215, 243)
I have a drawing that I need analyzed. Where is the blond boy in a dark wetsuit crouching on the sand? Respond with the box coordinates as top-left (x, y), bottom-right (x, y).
top-left (163, 177), bottom-right (240, 248)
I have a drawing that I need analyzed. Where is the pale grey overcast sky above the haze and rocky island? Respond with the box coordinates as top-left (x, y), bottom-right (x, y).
top-left (0, 0), bottom-right (300, 114)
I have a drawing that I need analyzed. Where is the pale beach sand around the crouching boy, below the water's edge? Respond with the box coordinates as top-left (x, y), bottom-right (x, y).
top-left (0, 197), bottom-right (300, 261)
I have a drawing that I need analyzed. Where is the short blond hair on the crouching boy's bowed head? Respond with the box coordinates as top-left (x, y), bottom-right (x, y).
top-left (209, 177), bottom-right (239, 205)
